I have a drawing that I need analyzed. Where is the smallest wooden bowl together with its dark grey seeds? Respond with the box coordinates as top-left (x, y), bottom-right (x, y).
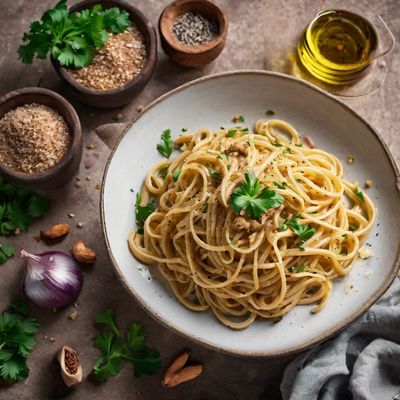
top-left (158, 0), bottom-right (228, 67)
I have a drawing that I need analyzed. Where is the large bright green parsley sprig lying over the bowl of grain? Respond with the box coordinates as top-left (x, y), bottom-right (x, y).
top-left (18, 0), bottom-right (131, 68)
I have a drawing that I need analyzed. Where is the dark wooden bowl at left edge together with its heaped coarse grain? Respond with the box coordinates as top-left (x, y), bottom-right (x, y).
top-left (0, 87), bottom-right (82, 189)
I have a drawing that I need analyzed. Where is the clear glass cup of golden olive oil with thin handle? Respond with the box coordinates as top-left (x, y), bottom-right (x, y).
top-left (297, 1), bottom-right (395, 97)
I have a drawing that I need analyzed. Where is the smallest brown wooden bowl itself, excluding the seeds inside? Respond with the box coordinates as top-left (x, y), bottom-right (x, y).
top-left (158, 0), bottom-right (228, 67)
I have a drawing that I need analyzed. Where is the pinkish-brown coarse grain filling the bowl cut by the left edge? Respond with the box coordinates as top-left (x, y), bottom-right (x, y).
top-left (0, 103), bottom-right (71, 174)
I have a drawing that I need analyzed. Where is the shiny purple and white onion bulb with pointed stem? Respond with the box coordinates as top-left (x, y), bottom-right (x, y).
top-left (21, 250), bottom-right (83, 309)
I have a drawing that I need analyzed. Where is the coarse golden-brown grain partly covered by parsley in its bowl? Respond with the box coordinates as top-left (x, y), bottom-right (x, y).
top-left (69, 25), bottom-right (147, 90)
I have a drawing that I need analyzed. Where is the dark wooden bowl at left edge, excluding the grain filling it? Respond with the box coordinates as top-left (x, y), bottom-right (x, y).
top-left (0, 87), bottom-right (82, 189)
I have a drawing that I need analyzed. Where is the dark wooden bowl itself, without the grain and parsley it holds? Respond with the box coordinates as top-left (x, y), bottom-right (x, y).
top-left (51, 0), bottom-right (157, 108)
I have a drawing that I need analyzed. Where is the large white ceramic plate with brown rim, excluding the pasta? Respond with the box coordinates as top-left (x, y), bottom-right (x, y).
top-left (101, 71), bottom-right (400, 356)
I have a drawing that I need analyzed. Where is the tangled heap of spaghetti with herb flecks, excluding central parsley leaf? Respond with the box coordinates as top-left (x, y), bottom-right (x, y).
top-left (128, 119), bottom-right (375, 329)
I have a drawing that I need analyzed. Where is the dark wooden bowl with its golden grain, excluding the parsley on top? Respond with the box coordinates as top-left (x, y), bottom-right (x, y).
top-left (51, 0), bottom-right (157, 108)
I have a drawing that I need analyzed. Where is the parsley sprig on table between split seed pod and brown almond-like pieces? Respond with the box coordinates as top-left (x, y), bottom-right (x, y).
top-left (93, 310), bottom-right (161, 383)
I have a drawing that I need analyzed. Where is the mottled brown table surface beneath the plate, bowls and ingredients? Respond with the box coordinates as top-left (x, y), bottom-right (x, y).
top-left (0, 0), bottom-right (400, 400)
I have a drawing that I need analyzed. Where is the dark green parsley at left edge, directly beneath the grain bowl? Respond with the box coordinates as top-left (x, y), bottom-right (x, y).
top-left (0, 176), bottom-right (49, 236)
